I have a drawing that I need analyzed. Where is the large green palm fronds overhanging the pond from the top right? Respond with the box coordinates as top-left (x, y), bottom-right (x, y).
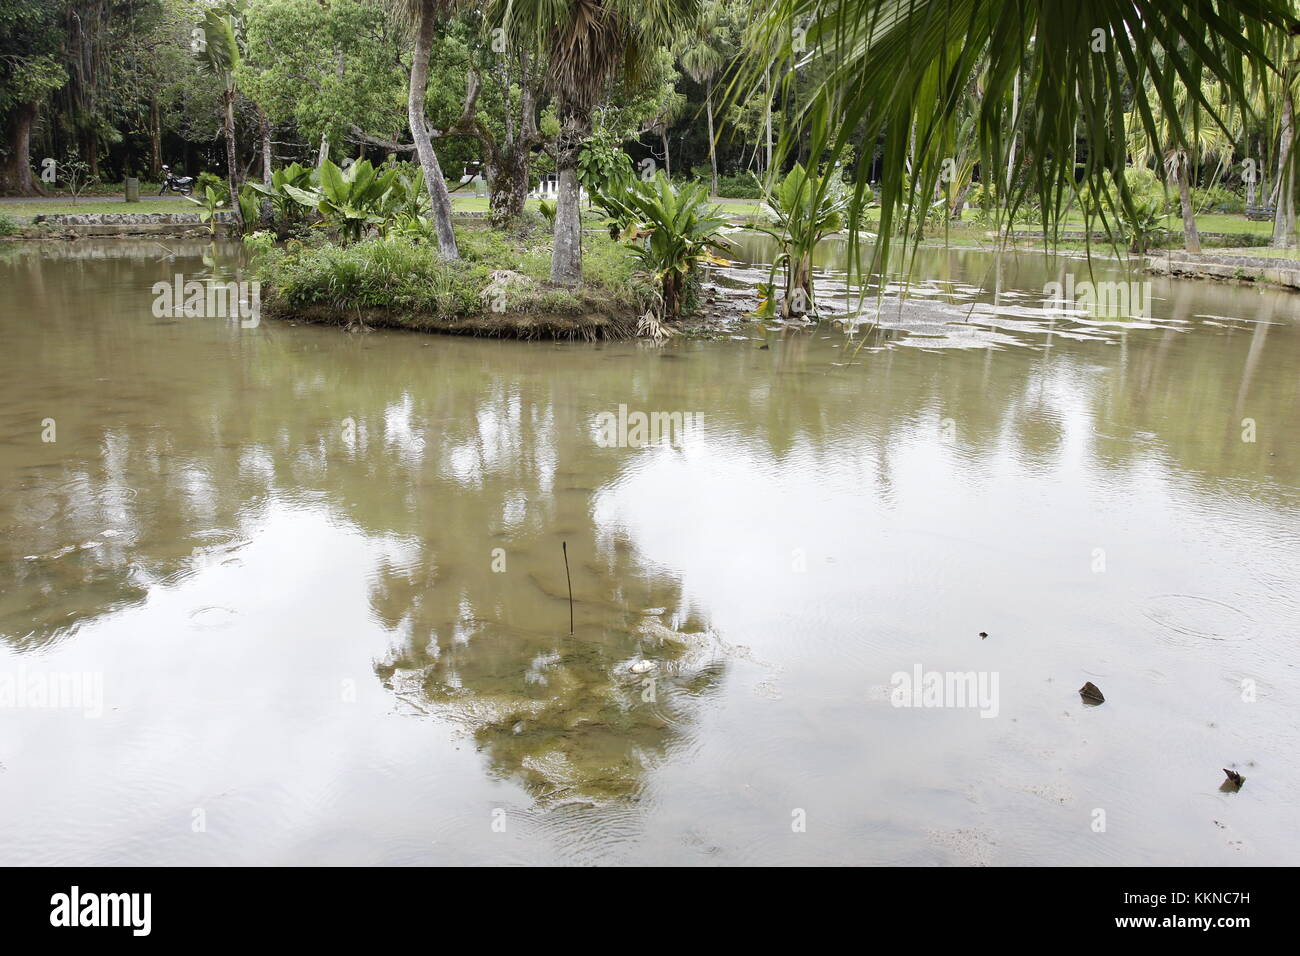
top-left (732, 0), bottom-right (1300, 273)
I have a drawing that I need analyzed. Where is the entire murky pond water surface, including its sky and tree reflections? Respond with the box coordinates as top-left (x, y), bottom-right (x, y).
top-left (0, 242), bottom-right (1300, 864)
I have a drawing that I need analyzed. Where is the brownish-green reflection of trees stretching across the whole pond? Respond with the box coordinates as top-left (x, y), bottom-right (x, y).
top-left (0, 240), bottom-right (1300, 799)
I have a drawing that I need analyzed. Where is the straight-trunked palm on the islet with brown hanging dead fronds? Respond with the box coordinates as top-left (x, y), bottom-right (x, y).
top-left (489, 0), bottom-right (699, 285)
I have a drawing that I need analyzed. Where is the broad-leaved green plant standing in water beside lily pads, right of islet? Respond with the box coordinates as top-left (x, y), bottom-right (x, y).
top-left (754, 163), bottom-right (849, 319)
